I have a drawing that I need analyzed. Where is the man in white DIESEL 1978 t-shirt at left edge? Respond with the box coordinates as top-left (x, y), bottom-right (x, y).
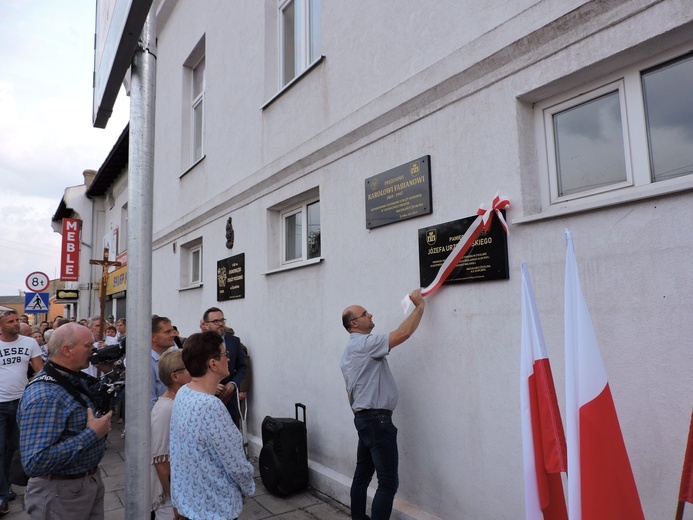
top-left (0, 310), bottom-right (43, 515)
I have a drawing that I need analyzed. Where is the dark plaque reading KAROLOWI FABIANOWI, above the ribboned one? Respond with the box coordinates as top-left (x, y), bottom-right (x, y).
top-left (366, 155), bottom-right (433, 229)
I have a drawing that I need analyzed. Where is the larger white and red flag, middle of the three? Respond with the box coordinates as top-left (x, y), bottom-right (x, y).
top-left (565, 230), bottom-right (645, 520)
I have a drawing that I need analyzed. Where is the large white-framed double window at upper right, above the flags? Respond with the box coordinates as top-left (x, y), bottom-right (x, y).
top-left (535, 47), bottom-right (693, 209)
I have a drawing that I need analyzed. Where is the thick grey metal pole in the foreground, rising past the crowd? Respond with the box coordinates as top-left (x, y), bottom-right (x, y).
top-left (125, 8), bottom-right (157, 518)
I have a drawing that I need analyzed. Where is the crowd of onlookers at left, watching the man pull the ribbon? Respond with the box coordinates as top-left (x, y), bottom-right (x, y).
top-left (0, 307), bottom-right (255, 520)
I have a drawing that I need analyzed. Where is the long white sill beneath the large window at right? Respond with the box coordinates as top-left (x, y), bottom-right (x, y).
top-left (512, 175), bottom-right (693, 224)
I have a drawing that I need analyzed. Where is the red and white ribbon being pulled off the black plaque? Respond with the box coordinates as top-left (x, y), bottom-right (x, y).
top-left (402, 194), bottom-right (510, 314)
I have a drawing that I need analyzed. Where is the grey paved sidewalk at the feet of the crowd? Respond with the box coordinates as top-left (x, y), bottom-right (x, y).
top-left (2, 421), bottom-right (350, 520)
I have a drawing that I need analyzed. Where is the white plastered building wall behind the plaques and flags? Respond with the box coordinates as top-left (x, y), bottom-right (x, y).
top-left (147, 0), bottom-right (693, 519)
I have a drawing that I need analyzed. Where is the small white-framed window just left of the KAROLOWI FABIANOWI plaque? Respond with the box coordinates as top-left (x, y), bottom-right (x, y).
top-left (281, 200), bottom-right (320, 265)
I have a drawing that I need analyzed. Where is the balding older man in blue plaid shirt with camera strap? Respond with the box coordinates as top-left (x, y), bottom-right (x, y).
top-left (17, 323), bottom-right (111, 520)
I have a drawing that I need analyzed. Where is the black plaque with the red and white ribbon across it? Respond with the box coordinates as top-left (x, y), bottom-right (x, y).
top-left (419, 211), bottom-right (510, 287)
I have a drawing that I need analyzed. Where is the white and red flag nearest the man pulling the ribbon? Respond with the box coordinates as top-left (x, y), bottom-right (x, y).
top-left (520, 262), bottom-right (568, 520)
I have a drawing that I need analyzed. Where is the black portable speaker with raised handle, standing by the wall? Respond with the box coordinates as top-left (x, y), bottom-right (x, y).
top-left (260, 403), bottom-right (308, 496)
